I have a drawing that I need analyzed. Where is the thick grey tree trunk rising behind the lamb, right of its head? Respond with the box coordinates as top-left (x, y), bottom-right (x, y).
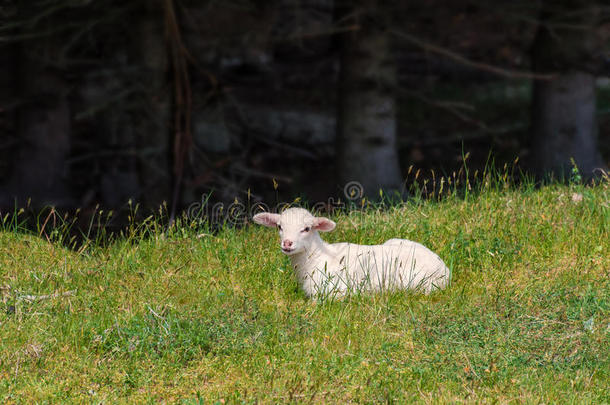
top-left (337, 2), bottom-right (401, 197)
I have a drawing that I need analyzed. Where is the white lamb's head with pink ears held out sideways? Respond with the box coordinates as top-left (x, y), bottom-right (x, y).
top-left (252, 208), bottom-right (335, 255)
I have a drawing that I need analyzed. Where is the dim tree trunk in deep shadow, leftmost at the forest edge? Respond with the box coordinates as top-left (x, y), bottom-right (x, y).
top-left (7, 37), bottom-right (72, 206)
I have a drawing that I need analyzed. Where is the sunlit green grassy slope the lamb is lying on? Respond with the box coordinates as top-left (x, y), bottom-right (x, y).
top-left (0, 184), bottom-right (610, 403)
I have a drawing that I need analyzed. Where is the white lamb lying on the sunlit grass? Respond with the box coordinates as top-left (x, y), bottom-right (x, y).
top-left (253, 208), bottom-right (451, 297)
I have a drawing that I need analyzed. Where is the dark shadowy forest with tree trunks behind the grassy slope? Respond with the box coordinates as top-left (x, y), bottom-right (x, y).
top-left (0, 0), bottom-right (610, 218)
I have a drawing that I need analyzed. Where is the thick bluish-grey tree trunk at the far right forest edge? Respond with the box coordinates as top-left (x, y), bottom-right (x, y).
top-left (532, 0), bottom-right (603, 177)
